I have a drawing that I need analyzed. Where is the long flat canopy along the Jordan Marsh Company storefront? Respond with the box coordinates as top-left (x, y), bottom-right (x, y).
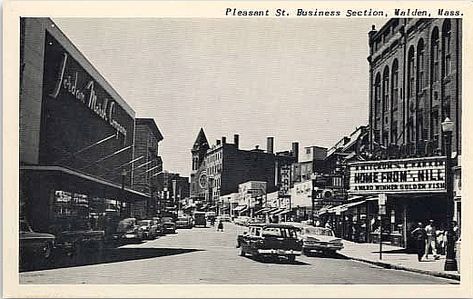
top-left (20, 165), bottom-right (150, 202)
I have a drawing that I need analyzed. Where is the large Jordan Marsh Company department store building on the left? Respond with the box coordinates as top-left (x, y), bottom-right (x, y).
top-left (19, 18), bottom-right (149, 233)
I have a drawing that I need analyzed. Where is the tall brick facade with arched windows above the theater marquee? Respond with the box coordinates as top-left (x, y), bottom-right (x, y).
top-left (368, 19), bottom-right (462, 156)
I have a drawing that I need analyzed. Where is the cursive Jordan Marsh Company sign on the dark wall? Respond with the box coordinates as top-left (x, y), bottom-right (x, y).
top-left (49, 52), bottom-right (127, 138)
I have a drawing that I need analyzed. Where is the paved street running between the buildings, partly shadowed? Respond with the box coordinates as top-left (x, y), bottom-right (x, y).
top-left (20, 223), bottom-right (457, 284)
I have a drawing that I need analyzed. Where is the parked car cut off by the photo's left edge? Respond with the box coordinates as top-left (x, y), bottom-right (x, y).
top-left (20, 220), bottom-right (56, 264)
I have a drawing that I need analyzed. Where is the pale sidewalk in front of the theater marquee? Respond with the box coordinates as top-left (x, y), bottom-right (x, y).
top-left (339, 240), bottom-right (460, 280)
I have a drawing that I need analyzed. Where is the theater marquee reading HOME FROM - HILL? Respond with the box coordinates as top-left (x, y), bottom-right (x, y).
top-left (349, 157), bottom-right (446, 194)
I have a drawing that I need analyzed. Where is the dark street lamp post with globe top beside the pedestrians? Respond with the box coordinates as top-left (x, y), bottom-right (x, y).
top-left (442, 117), bottom-right (457, 271)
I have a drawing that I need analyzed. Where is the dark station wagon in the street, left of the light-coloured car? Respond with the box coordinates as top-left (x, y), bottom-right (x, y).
top-left (237, 223), bottom-right (302, 262)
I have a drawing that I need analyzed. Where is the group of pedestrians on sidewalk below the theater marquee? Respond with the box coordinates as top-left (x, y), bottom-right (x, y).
top-left (411, 220), bottom-right (458, 262)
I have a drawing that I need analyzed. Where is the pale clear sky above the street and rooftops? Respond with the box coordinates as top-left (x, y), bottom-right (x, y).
top-left (54, 18), bottom-right (386, 176)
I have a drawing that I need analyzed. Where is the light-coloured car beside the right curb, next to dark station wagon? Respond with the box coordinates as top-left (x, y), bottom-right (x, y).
top-left (300, 226), bottom-right (343, 255)
